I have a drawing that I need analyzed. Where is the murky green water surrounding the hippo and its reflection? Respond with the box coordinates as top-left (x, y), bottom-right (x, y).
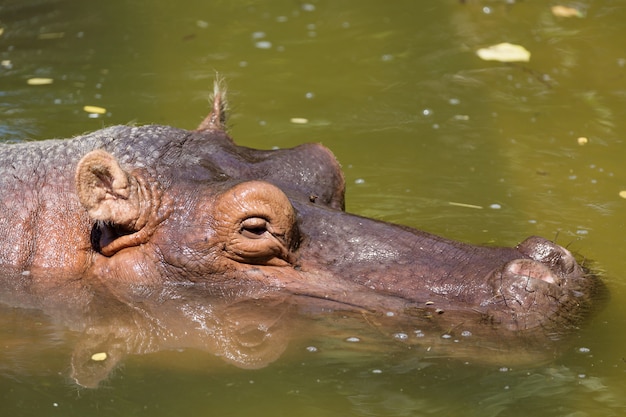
top-left (0, 0), bottom-right (626, 417)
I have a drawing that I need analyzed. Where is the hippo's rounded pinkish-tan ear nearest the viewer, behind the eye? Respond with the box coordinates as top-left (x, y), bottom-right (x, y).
top-left (76, 150), bottom-right (140, 228)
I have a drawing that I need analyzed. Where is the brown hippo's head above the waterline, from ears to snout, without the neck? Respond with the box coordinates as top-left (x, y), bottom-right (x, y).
top-left (70, 90), bottom-right (601, 352)
